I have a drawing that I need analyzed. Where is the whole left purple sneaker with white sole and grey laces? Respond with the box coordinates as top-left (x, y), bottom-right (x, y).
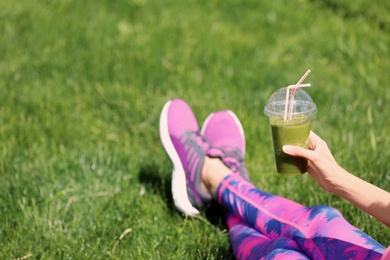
top-left (160, 99), bottom-right (211, 216)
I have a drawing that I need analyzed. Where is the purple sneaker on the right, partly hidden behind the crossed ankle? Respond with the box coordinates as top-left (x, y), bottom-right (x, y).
top-left (201, 110), bottom-right (249, 181)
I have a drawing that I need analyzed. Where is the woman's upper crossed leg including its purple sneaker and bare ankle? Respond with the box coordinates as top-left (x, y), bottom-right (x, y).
top-left (160, 100), bottom-right (384, 259)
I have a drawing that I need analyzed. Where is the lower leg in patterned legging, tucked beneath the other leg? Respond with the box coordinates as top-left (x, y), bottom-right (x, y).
top-left (226, 213), bottom-right (310, 260)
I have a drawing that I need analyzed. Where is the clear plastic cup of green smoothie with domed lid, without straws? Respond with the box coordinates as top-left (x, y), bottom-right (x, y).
top-left (264, 87), bottom-right (317, 175)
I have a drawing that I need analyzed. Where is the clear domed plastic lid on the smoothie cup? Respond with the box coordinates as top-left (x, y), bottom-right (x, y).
top-left (264, 87), bottom-right (317, 117)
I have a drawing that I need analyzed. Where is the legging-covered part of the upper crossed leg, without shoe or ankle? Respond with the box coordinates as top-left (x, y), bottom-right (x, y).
top-left (215, 174), bottom-right (385, 259)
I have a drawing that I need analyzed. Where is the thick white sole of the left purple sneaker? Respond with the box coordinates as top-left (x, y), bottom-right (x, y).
top-left (160, 101), bottom-right (199, 216)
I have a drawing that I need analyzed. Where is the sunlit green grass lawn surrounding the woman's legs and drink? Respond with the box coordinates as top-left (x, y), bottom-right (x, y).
top-left (0, 0), bottom-right (390, 259)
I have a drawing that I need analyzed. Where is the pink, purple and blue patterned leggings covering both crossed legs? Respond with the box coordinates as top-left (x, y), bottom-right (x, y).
top-left (216, 174), bottom-right (385, 259)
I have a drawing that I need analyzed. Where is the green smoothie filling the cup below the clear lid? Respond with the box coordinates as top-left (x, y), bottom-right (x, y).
top-left (271, 118), bottom-right (310, 175)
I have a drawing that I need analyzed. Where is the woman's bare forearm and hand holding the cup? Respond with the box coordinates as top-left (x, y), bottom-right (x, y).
top-left (283, 132), bottom-right (390, 227)
